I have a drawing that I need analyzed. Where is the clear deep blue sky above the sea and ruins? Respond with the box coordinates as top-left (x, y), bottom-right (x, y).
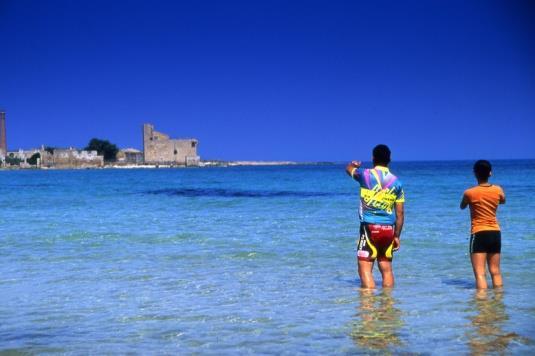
top-left (0, 0), bottom-right (535, 161)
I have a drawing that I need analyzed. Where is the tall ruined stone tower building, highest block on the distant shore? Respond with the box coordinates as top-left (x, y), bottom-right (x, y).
top-left (143, 124), bottom-right (200, 166)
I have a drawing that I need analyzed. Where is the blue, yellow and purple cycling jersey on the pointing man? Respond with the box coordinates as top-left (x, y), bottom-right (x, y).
top-left (351, 166), bottom-right (405, 225)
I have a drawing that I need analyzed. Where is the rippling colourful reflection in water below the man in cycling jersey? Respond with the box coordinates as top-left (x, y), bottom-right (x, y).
top-left (351, 289), bottom-right (403, 351)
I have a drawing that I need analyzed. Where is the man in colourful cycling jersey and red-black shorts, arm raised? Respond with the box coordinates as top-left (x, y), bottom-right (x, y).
top-left (346, 145), bottom-right (405, 288)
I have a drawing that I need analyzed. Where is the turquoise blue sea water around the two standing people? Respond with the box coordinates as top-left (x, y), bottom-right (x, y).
top-left (0, 161), bottom-right (535, 354)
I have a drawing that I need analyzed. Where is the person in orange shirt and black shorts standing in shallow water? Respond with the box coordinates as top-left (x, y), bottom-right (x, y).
top-left (461, 160), bottom-right (505, 289)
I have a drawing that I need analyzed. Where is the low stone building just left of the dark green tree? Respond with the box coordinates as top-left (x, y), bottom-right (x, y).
top-left (40, 147), bottom-right (104, 168)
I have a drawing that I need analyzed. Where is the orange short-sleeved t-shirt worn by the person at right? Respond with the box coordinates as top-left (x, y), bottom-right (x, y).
top-left (464, 184), bottom-right (505, 234)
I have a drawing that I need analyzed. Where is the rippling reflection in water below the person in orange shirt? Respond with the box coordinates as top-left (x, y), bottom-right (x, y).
top-left (468, 289), bottom-right (524, 355)
